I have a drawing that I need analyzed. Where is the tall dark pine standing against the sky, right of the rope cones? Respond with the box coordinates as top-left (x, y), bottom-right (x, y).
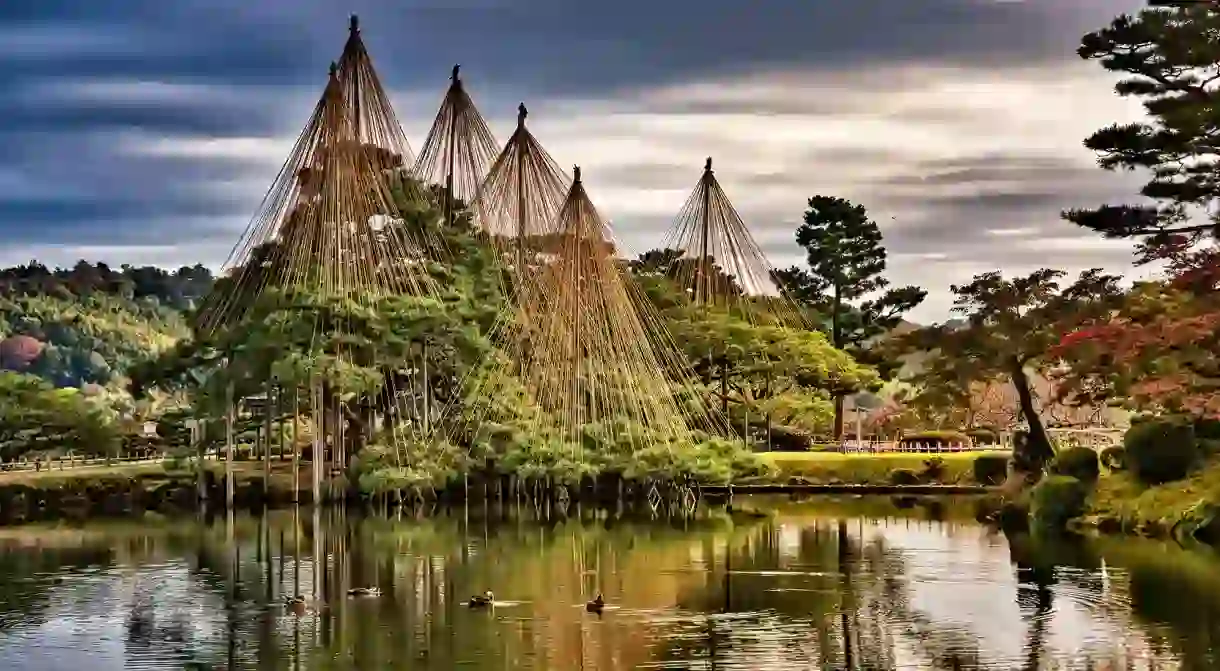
top-left (775, 195), bottom-right (927, 440)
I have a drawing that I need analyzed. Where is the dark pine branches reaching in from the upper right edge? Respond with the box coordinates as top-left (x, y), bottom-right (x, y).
top-left (1064, 4), bottom-right (1220, 261)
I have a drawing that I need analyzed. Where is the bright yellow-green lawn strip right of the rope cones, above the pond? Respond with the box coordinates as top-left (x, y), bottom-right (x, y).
top-left (759, 450), bottom-right (1008, 484)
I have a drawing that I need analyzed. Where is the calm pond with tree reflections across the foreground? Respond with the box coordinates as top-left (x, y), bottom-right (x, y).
top-left (0, 498), bottom-right (1220, 671)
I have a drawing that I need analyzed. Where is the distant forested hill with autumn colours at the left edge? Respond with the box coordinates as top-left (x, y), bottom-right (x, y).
top-left (0, 261), bottom-right (214, 387)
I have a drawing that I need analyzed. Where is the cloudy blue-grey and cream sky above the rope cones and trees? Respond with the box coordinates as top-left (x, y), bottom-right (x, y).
top-left (0, 0), bottom-right (1143, 321)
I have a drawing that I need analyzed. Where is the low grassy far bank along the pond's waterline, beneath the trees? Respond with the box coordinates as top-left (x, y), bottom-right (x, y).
top-left (0, 453), bottom-right (1010, 525)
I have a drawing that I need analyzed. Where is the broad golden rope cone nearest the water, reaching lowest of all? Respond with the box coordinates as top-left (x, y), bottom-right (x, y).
top-left (444, 163), bottom-right (723, 458)
